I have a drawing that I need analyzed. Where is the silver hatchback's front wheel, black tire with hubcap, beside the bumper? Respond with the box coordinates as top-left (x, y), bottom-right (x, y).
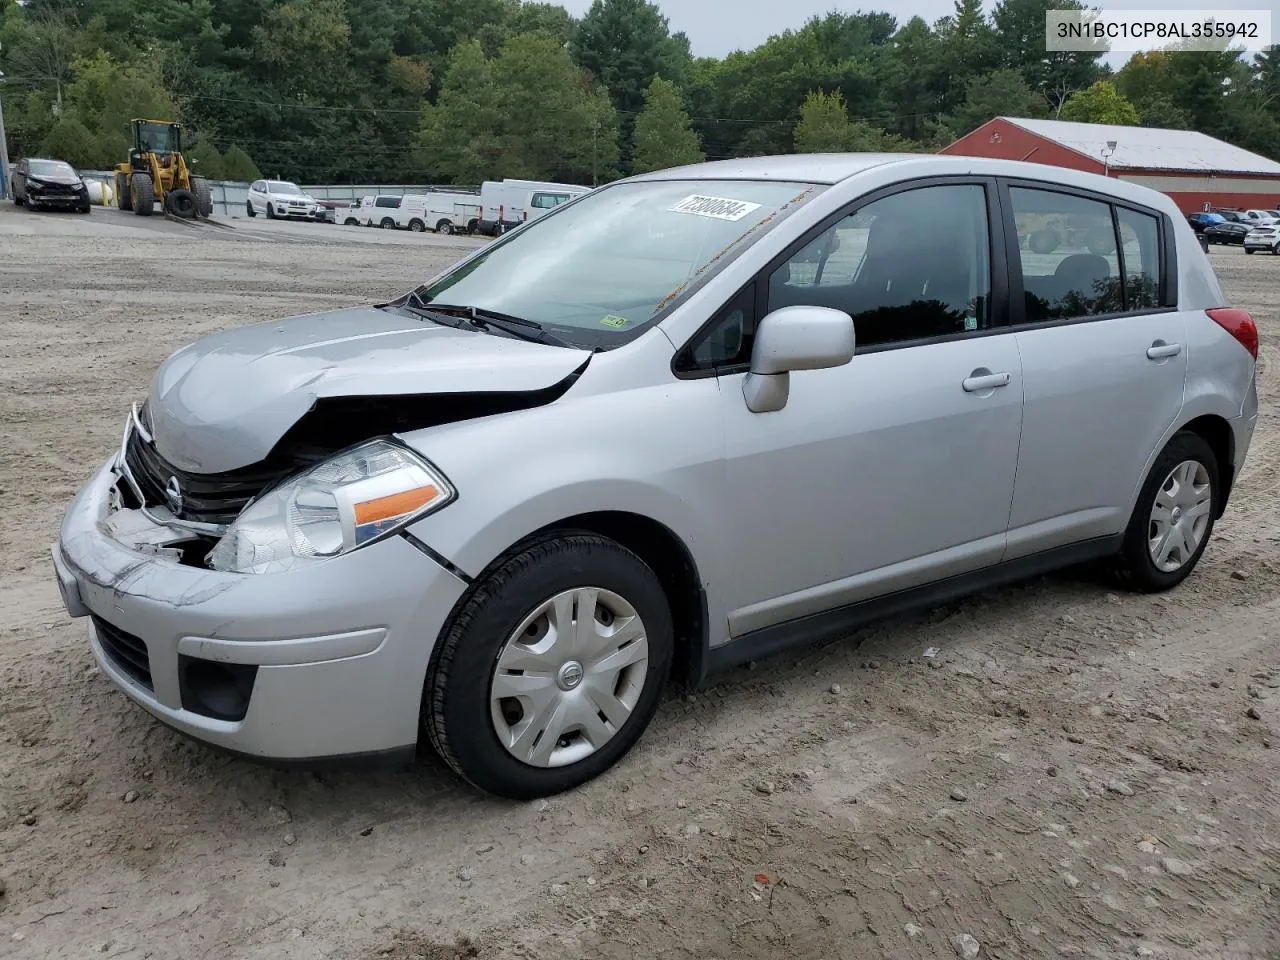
top-left (422, 532), bottom-right (675, 800)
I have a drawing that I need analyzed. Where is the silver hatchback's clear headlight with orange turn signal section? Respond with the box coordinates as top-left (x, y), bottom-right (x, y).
top-left (209, 440), bottom-right (457, 573)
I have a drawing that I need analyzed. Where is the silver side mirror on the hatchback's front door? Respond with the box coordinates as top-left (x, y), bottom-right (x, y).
top-left (742, 307), bottom-right (854, 413)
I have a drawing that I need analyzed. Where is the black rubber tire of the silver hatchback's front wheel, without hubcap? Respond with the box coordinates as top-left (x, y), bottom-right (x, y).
top-left (422, 532), bottom-right (675, 800)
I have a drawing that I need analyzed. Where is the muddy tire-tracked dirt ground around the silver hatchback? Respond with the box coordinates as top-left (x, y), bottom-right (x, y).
top-left (0, 206), bottom-right (1280, 960)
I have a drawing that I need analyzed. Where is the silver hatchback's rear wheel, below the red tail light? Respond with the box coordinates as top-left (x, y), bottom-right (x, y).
top-left (1116, 433), bottom-right (1220, 593)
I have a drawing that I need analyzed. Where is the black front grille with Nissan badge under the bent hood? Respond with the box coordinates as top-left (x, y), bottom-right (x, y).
top-left (124, 430), bottom-right (320, 524)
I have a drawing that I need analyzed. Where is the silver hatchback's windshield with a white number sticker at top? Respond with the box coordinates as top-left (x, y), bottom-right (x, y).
top-left (419, 180), bottom-right (823, 346)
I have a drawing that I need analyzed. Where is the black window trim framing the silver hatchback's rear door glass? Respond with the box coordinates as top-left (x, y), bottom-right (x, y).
top-left (996, 177), bottom-right (1178, 330)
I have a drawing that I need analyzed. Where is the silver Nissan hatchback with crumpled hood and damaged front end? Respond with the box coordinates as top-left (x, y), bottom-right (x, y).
top-left (52, 155), bottom-right (1257, 797)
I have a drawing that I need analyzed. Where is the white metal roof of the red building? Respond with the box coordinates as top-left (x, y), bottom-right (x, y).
top-left (1000, 116), bottom-right (1280, 177)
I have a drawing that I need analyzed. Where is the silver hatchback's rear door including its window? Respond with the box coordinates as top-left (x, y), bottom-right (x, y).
top-left (1002, 182), bottom-right (1188, 559)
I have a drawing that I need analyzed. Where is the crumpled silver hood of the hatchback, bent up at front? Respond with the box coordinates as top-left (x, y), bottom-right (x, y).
top-left (147, 307), bottom-right (590, 474)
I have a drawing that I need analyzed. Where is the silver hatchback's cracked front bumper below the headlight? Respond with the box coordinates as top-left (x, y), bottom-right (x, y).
top-left (52, 460), bottom-right (466, 762)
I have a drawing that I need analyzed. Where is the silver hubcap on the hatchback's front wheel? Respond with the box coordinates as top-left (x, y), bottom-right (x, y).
top-left (489, 586), bottom-right (649, 767)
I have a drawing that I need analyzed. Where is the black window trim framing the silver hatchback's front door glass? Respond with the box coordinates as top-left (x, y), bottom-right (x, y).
top-left (671, 174), bottom-right (1016, 380)
